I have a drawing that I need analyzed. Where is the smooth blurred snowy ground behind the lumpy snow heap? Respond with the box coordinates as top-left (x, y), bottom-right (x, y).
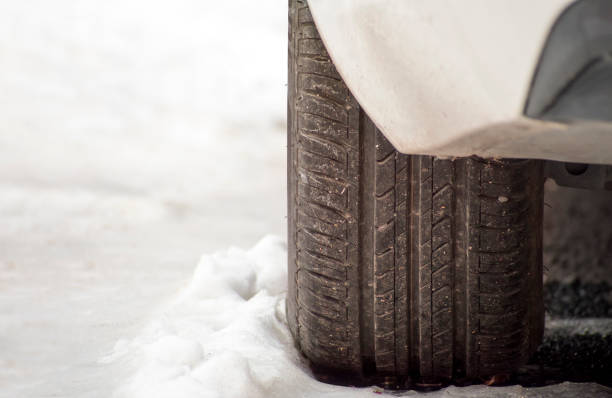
top-left (0, 0), bottom-right (287, 398)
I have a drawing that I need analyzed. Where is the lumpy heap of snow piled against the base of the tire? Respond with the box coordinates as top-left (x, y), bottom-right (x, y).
top-left (106, 236), bottom-right (602, 398)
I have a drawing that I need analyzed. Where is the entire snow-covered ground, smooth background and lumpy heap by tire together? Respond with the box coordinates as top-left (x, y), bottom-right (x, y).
top-left (0, 0), bottom-right (608, 398)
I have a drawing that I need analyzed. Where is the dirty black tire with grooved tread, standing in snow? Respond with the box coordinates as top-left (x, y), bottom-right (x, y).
top-left (287, 0), bottom-right (544, 382)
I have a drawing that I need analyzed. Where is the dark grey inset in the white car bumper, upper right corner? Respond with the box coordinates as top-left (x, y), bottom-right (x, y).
top-left (524, 0), bottom-right (612, 121)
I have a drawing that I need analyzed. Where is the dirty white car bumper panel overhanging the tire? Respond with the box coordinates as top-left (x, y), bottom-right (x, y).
top-left (309, 0), bottom-right (612, 163)
